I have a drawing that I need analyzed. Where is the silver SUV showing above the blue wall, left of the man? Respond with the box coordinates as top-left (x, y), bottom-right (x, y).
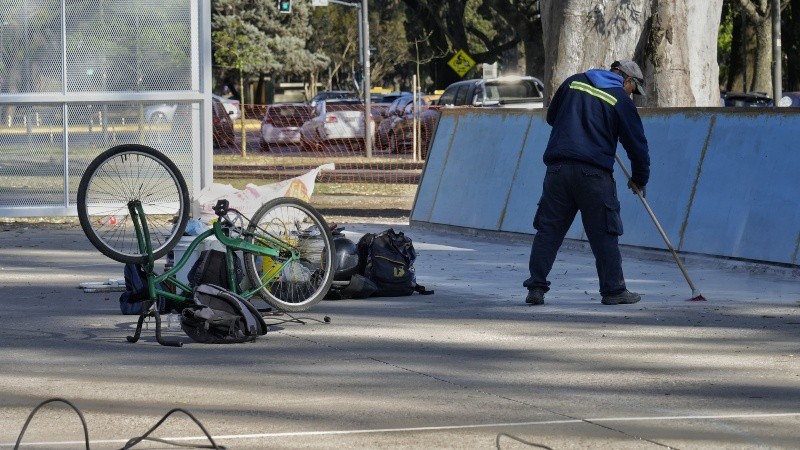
top-left (438, 76), bottom-right (544, 109)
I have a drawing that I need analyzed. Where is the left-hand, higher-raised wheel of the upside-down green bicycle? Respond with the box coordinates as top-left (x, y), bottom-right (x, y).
top-left (77, 144), bottom-right (189, 264)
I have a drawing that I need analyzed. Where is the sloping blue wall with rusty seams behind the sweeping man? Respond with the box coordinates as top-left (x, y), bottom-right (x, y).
top-left (411, 108), bottom-right (800, 265)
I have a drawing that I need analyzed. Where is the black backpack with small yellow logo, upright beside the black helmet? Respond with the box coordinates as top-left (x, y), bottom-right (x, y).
top-left (357, 228), bottom-right (433, 297)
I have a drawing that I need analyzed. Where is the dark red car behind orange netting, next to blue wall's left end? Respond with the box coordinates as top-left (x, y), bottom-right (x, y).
top-left (388, 102), bottom-right (440, 159)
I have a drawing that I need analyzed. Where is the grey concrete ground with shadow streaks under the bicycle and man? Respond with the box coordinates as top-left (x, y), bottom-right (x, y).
top-left (0, 220), bottom-right (800, 449)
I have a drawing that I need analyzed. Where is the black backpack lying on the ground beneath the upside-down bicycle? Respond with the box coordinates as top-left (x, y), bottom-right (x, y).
top-left (181, 284), bottom-right (267, 344)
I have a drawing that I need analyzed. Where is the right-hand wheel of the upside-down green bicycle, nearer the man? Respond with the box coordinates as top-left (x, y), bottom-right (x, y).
top-left (244, 197), bottom-right (336, 312)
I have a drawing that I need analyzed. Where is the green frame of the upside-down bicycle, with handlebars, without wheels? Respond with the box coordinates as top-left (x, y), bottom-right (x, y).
top-left (127, 200), bottom-right (300, 347)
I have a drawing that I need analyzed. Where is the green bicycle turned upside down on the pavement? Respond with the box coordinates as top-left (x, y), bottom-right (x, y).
top-left (77, 144), bottom-right (336, 346)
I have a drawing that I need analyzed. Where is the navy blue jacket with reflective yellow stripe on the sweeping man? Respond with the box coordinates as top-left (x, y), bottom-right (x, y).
top-left (543, 69), bottom-right (650, 187)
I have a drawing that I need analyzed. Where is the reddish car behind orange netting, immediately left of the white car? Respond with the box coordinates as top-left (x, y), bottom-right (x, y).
top-left (260, 103), bottom-right (314, 152)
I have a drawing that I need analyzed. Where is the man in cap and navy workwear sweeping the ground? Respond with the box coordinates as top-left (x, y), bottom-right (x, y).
top-left (523, 59), bottom-right (650, 305)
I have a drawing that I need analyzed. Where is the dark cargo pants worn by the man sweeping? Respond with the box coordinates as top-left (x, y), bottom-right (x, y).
top-left (523, 163), bottom-right (625, 295)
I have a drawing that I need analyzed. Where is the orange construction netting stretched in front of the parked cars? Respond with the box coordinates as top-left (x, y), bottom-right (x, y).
top-left (214, 101), bottom-right (446, 184)
